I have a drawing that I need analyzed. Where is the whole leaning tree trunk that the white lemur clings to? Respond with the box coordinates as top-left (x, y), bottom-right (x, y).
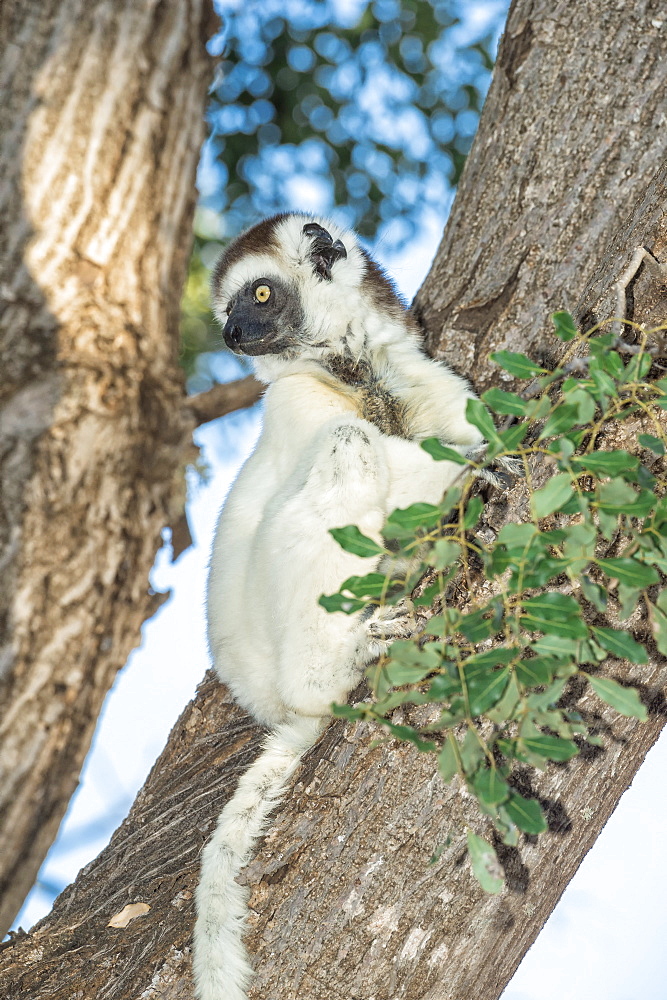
top-left (0, 0), bottom-right (667, 1000)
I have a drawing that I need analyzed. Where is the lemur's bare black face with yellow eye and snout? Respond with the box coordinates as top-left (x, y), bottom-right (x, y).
top-left (223, 277), bottom-right (303, 357)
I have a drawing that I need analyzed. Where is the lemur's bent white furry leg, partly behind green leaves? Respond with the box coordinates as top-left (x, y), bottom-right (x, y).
top-left (260, 416), bottom-right (389, 715)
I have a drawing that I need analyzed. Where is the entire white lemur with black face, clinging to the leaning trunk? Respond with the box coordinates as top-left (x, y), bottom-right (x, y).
top-left (194, 214), bottom-right (481, 1000)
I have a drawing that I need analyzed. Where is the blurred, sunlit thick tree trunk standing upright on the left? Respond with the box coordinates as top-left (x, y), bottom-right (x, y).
top-left (0, 0), bottom-right (215, 929)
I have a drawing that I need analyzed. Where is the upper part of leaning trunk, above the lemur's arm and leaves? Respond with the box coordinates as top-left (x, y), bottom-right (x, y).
top-left (414, 0), bottom-right (667, 384)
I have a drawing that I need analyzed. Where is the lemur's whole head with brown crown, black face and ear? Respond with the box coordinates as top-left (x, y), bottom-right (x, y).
top-left (212, 213), bottom-right (405, 370)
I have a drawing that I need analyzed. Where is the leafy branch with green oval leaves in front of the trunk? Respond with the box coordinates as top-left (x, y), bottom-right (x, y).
top-left (320, 312), bottom-right (667, 892)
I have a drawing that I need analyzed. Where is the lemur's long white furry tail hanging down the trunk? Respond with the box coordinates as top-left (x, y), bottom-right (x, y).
top-left (193, 718), bottom-right (322, 1000)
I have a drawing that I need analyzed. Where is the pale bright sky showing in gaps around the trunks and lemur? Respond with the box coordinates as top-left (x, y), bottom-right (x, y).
top-left (10, 0), bottom-right (667, 1000)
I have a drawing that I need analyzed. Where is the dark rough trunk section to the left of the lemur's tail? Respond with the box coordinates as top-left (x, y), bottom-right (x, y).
top-left (0, 671), bottom-right (259, 1000)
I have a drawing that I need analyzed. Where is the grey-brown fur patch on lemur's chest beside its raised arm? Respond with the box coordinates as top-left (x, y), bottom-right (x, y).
top-left (327, 355), bottom-right (410, 438)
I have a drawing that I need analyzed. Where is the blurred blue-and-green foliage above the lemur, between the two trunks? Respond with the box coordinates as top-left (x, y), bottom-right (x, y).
top-left (183, 0), bottom-right (507, 388)
